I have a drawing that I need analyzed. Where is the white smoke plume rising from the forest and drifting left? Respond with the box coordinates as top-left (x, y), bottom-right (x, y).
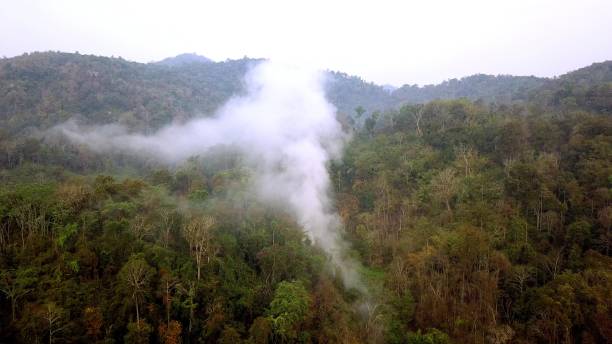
top-left (60, 61), bottom-right (365, 293)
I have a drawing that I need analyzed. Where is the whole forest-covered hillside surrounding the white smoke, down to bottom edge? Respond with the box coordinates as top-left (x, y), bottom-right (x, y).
top-left (0, 53), bottom-right (612, 343)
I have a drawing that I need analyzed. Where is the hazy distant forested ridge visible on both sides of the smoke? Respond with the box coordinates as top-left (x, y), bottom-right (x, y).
top-left (0, 52), bottom-right (612, 135)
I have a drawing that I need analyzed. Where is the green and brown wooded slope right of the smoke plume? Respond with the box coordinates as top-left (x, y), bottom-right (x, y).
top-left (335, 100), bottom-right (612, 343)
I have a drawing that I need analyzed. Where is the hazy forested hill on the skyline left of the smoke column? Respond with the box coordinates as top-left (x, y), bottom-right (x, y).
top-left (0, 52), bottom-right (257, 132)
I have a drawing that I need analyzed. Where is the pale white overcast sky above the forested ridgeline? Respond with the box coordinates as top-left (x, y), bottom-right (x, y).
top-left (0, 0), bottom-right (612, 86)
